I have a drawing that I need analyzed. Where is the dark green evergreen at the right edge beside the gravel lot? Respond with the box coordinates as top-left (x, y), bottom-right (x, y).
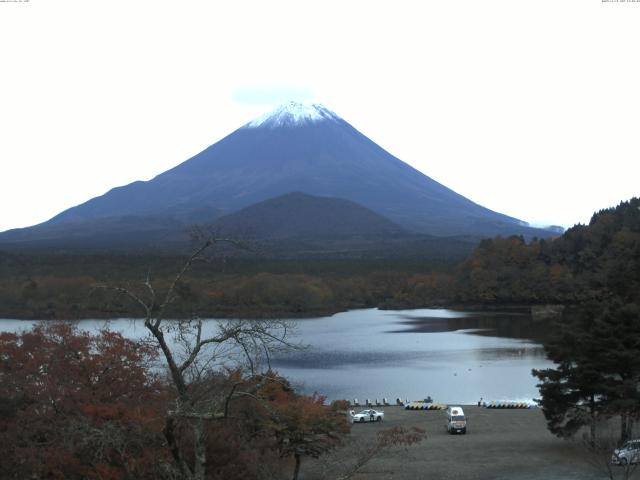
top-left (533, 297), bottom-right (640, 444)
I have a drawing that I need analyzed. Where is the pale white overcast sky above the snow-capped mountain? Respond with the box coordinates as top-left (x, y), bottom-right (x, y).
top-left (0, 0), bottom-right (640, 231)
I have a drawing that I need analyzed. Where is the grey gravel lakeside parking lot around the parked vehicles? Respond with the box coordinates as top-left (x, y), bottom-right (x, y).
top-left (303, 406), bottom-right (637, 480)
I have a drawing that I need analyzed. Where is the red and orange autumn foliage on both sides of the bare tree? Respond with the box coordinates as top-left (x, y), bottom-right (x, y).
top-left (0, 323), bottom-right (349, 480)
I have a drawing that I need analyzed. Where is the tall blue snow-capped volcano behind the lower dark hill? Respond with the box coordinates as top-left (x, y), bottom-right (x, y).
top-left (0, 102), bottom-right (553, 251)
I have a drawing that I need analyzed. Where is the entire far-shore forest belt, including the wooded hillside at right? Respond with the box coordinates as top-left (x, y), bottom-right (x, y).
top-left (0, 198), bottom-right (640, 319)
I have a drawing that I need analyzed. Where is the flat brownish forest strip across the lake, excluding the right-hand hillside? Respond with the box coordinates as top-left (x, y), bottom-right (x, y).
top-left (0, 251), bottom-right (453, 319)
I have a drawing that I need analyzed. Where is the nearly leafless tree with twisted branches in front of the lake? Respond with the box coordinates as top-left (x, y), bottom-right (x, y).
top-left (102, 238), bottom-right (295, 480)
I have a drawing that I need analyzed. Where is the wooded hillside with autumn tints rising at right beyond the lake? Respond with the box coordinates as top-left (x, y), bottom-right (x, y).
top-left (455, 198), bottom-right (640, 304)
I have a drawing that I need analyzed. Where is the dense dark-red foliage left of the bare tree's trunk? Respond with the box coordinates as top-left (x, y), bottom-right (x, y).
top-left (0, 323), bottom-right (166, 479)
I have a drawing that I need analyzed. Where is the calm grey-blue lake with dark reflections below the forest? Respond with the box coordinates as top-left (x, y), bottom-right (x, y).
top-left (0, 309), bottom-right (553, 404)
